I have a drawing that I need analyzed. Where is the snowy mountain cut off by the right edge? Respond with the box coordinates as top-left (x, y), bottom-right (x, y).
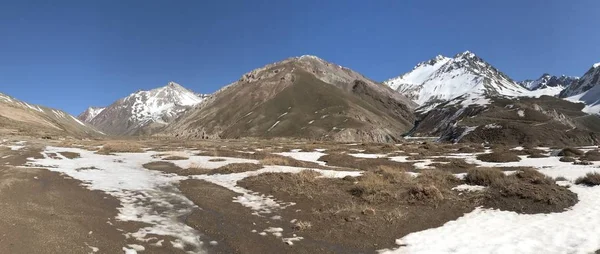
top-left (559, 63), bottom-right (600, 114)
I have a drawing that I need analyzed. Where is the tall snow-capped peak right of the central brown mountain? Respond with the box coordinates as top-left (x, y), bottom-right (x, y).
top-left (384, 51), bottom-right (529, 106)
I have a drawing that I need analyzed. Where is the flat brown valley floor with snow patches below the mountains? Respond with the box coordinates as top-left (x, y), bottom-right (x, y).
top-left (0, 136), bottom-right (600, 253)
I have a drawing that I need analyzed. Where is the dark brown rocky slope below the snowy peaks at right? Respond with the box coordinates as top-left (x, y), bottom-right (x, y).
top-left (410, 96), bottom-right (600, 146)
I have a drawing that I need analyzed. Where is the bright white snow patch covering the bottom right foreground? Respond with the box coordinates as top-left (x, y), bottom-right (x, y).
top-left (381, 148), bottom-right (600, 253)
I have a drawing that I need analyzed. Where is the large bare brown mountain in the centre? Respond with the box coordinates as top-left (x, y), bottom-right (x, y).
top-left (162, 56), bottom-right (416, 142)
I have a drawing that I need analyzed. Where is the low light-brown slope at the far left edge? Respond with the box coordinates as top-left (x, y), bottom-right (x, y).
top-left (0, 93), bottom-right (103, 137)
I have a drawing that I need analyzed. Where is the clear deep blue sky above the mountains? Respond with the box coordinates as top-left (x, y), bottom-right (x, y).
top-left (0, 0), bottom-right (600, 114)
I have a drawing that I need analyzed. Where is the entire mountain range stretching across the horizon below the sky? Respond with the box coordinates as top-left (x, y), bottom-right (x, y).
top-left (0, 51), bottom-right (600, 144)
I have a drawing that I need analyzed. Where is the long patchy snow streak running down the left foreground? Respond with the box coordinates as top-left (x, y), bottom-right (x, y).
top-left (28, 146), bottom-right (202, 251)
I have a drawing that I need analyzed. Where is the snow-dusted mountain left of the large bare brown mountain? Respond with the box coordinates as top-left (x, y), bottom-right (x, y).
top-left (84, 82), bottom-right (203, 135)
